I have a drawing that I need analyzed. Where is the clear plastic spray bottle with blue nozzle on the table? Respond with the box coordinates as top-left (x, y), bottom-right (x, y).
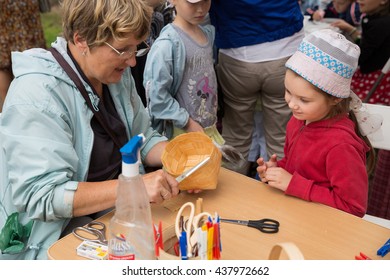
top-left (108, 134), bottom-right (156, 260)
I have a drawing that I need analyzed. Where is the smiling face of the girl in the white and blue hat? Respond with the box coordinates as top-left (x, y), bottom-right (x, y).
top-left (284, 69), bottom-right (340, 124)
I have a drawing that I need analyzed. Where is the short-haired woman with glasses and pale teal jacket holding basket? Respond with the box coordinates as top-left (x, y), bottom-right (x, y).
top-left (0, 0), bottom-right (178, 259)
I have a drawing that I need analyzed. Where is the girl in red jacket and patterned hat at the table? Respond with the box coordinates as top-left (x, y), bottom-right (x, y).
top-left (257, 29), bottom-right (380, 217)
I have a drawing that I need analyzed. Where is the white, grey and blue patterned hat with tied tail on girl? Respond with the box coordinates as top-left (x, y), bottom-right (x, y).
top-left (286, 29), bottom-right (383, 136)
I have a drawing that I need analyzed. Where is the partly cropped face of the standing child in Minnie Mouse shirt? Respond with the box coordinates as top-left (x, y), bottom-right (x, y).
top-left (171, 0), bottom-right (211, 25)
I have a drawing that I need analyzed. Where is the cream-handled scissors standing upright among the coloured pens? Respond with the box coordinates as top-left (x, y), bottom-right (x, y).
top-left (175, 202), bottom-right (211, 257)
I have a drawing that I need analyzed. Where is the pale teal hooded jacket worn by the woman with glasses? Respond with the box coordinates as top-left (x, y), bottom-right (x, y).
top-left (0, 38), bottom-right (167, 259)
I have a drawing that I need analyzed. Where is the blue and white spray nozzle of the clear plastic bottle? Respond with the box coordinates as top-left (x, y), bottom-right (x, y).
top-left (120, 134), bottom-right (145, 177)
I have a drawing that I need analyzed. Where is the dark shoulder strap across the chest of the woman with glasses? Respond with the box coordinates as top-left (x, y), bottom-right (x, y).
top-left (48, 47), bottom-right (122, 148)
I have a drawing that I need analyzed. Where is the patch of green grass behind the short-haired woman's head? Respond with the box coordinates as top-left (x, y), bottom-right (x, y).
top-left (41, 5), bottom-right (62, 47)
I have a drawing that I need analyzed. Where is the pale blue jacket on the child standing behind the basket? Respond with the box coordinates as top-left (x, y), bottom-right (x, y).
top-left (144, 24), bottom-right (215, 138)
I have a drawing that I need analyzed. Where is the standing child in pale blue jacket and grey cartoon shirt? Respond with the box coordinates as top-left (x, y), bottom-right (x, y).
top-left (144, 0), bottom-right (224, 144)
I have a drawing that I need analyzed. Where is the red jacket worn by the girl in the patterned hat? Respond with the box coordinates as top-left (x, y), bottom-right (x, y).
top-left (278, 116), bottom-right (369, 217)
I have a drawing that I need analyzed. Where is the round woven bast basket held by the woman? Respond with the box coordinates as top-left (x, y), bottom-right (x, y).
top-left (161, 132), bottom-right (222, 190)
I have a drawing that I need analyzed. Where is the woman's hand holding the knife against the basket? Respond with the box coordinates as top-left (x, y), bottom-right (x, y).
top-left (142, 169), bottom-right (179, 203)
